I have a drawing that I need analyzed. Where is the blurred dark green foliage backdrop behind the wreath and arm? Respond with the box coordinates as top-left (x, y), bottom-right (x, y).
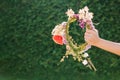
top-left (0, 0), bottom-right (120, 80)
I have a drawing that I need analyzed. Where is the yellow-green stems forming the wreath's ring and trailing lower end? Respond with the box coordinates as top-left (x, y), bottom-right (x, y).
top-left (65, 21), bottom-right (96, 71)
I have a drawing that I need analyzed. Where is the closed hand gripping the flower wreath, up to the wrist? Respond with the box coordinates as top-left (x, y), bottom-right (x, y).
top-left (84, 29), bottom-right (100, 46)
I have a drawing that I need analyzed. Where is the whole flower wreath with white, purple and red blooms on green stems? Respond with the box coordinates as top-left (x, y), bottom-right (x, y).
top-left (52, 6), bottom-right (96, 71)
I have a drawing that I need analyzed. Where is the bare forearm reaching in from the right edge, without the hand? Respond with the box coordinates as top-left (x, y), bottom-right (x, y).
top-left (94, 39), bottom-right (120, 56)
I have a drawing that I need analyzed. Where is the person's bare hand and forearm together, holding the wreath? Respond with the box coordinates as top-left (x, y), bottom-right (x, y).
top-left (84, 29), bottom-right (120, 56)
